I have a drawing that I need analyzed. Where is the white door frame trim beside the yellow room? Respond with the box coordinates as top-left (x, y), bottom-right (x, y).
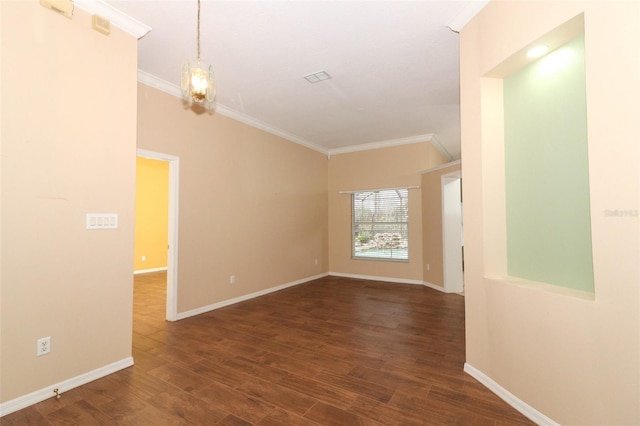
top-left (137, 149), bottom-right (180, 321)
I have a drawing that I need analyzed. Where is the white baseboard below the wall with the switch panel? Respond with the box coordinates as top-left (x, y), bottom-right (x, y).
top-left (0, 357), bottom-right (133, 417)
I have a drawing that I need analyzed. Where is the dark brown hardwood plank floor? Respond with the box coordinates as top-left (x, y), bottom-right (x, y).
top-left (0, 273), bottom-right (532, 426)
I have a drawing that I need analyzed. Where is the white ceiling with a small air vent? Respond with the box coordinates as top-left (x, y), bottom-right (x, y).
top-left (106, 0), bottom-right (486, 159)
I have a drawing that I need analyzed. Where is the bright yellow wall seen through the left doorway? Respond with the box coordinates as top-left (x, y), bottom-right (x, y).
top-left (133, 157), bottom-right (169, 271)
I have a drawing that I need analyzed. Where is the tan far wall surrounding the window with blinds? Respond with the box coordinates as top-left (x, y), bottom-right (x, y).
top-left (329, 141), bottom-right (446, 282)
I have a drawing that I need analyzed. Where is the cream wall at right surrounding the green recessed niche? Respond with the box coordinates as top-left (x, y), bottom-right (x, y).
top-left (460, 2), bottom-right (640, 425)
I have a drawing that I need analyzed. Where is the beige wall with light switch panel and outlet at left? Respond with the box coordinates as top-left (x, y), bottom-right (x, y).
top-left (0, 1), bottom-right (137, 402)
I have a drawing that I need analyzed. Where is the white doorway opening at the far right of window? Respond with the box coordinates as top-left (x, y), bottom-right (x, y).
top-left (441, 171), bottom-right (464, 293)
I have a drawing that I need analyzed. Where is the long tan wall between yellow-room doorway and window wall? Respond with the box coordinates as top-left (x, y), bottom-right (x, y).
top-left (138, 85), bottom-right (328, 313)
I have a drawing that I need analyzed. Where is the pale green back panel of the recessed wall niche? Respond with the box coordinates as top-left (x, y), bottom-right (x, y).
top-left (504, 36), bottom-right (594, 292)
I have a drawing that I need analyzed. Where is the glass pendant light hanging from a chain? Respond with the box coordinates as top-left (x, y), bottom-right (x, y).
top-left (181, 0), bottom-right (216, 110)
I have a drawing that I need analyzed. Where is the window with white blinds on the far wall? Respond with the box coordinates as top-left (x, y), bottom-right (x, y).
top-left (351, 189), bottom-right (409, 261)
